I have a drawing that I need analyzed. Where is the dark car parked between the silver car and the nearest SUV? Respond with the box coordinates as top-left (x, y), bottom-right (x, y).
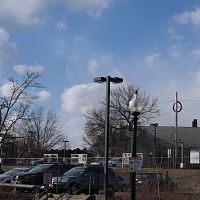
top-left (15, 163), bottom-right (75, 185)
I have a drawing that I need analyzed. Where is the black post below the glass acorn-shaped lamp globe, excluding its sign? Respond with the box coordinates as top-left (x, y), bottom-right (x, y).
top-left (130, 112), bottom-right (139, 200)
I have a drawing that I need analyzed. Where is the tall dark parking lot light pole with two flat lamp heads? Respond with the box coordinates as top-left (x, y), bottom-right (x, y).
top-left (94, 76), bottom-right (123, 200)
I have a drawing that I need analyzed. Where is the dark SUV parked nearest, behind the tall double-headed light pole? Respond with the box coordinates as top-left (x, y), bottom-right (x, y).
top-left (52, 165), bottom-right (119, 194)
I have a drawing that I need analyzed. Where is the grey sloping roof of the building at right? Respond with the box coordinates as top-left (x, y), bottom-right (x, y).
top-left (141, 126), bottom-right (200, 148)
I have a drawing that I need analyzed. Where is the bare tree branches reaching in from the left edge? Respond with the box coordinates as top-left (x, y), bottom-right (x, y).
top-left (0, 73), bottom-right (42, 144)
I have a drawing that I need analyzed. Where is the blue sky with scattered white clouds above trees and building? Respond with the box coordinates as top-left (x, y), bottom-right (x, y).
top-left (0, 0), bottom-right (200, 148)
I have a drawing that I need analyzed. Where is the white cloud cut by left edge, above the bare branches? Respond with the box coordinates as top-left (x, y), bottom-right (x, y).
top-left (0, 28), bottom-right (16, 64)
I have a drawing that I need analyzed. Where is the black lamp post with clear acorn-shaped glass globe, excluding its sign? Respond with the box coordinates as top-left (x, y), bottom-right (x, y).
top-left (129, 90), bottom-right (143, 200)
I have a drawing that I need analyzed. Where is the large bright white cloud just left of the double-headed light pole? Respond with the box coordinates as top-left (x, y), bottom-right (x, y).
top-left (61, 83), bottom-right (104, 114)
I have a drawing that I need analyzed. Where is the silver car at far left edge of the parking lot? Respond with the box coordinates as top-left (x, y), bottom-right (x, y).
top-left (0, 167), bottom-right (30, 183)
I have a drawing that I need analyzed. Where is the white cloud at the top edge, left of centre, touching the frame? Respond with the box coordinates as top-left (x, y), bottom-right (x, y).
top-left (63, 0), bottom-right (116, 18)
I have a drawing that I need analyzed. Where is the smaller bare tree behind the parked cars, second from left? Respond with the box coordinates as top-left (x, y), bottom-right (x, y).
top-left (16, 107), bottom-right (66, 157)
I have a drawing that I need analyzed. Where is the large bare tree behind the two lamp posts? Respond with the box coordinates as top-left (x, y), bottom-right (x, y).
top-left (83, 85), bottom-right (160, 154)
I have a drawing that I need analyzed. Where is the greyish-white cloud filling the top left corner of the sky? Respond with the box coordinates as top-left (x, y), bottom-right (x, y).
top-left (0, 0), bottom-right (52, 25)
